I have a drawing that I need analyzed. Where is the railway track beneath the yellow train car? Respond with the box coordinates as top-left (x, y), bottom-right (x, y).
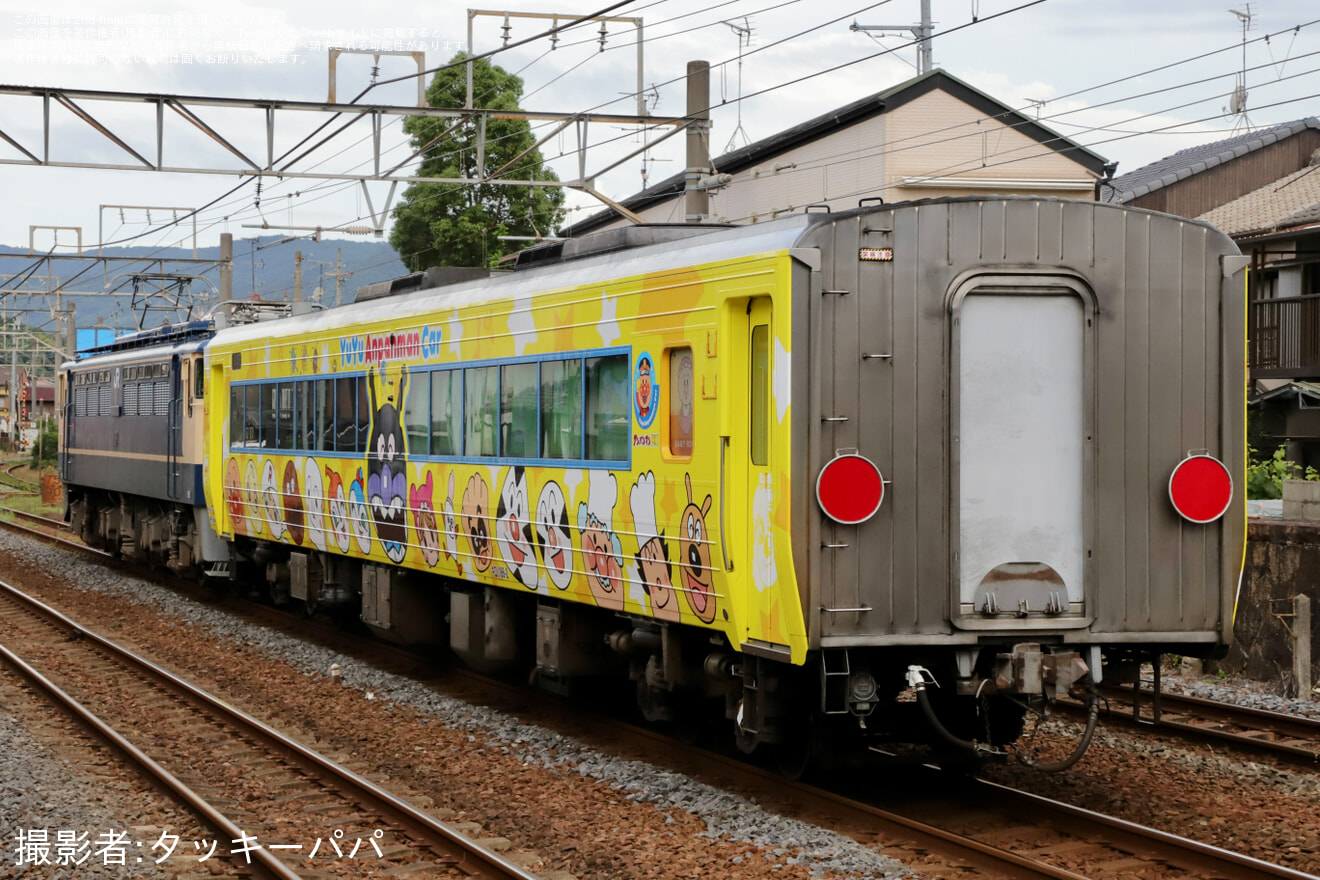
top-left (5, 524), bottom-right (1311, 880)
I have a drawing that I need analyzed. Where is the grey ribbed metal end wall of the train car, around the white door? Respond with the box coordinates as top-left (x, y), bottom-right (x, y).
top-left (795, 198), bottom-right (1243, 654)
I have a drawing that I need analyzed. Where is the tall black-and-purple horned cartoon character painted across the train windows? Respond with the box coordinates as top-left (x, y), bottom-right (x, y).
top-left (367, 367), bottom-right (408, 562)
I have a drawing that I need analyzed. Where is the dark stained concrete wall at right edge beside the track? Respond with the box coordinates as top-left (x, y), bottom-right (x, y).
top-left (1222, 520), bottom-right (1320, 693)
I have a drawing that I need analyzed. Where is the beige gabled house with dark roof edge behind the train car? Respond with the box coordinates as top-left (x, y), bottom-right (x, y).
top-left (558, 70), bottom-right (1113, 237)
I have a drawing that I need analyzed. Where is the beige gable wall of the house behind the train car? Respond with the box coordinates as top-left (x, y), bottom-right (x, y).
top-left (583, 90), bottom-right (1096, 228)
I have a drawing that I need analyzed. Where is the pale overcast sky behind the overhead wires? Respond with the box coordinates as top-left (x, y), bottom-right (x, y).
top-left (0, 0), bottom-right (1320, 271)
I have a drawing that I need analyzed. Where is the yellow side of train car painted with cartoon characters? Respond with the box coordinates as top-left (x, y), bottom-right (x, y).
top-left (206, 221), bottom-right (807, 696)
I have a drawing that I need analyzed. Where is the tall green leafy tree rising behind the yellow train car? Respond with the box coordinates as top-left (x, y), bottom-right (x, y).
top-left (389, 53), bottom-right (564, 272)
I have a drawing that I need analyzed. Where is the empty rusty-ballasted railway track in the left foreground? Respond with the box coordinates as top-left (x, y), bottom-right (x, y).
top-left (0, 582), bottom-right (535, 880)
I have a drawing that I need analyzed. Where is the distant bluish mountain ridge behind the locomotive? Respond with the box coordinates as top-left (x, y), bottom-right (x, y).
top-left (0, 235), bottom-right (408, 330)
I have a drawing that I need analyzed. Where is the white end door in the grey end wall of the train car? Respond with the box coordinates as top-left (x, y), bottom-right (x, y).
top-left (952, 277), bottom-right (1094, 629)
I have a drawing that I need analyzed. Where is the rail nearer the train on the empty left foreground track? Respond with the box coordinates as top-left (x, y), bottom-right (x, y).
top-left (0, 581), bottom-right (536, 880)
